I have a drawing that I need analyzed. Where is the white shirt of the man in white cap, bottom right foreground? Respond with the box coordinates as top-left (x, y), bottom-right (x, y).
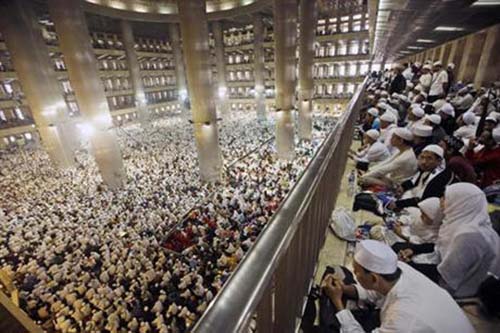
top-left (337, 262), bottom-right (475, 333)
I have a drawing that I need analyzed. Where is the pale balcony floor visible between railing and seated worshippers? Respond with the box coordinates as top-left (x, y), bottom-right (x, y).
top-left (315, 143), bottom-right (500, 333)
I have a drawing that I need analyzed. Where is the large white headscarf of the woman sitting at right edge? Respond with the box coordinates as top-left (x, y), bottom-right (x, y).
top-left (436, 183), bottom-right (498, 261)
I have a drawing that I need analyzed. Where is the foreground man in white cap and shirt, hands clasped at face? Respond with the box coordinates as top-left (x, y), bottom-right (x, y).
top-left (323, 240), bottom-right (474, 333)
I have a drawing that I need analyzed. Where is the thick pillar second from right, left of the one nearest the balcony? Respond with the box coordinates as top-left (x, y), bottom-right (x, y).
top-left (274, 0), bottom-right (297, 160)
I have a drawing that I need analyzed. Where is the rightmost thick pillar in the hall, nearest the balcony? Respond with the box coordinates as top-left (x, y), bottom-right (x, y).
top-left (299, 0), bottom-right (317, 140)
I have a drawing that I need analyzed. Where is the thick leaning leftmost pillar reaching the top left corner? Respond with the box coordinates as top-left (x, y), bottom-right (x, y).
top-left (0, 1), bottom-right (74, 168)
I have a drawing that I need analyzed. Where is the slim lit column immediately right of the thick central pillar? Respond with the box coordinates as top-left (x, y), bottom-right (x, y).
top-left (212, 21), bottom-right (229, 115)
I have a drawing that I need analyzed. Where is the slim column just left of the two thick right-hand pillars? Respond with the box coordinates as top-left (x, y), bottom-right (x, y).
top-left (253, 15), bottom-right (266, 119)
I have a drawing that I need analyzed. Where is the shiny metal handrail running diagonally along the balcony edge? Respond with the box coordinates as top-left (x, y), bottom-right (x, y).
top-left (193, 78), bottom-right (367, 333)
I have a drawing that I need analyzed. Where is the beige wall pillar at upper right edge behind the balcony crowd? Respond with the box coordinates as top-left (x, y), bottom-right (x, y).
top-left (474, 24), bottom-right (500, 88)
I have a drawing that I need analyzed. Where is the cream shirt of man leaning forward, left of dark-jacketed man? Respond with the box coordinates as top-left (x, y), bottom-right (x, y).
top-left (363, 148), bottom-right (418, 183)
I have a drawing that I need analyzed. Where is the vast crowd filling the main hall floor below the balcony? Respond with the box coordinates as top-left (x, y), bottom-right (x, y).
top-left (0, 112), bottom-right (335, 333)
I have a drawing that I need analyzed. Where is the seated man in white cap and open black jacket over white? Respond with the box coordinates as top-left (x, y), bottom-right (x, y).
top-left (388, 145), bottom-right (456, 210)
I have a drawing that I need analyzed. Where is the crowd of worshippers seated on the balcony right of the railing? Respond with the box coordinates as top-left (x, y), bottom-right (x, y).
top-left (323, 61), bottom-right (500, 332)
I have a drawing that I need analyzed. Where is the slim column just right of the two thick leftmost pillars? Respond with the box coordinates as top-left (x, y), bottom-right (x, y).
top-left (121, 20), bottom-right (148, 126)
